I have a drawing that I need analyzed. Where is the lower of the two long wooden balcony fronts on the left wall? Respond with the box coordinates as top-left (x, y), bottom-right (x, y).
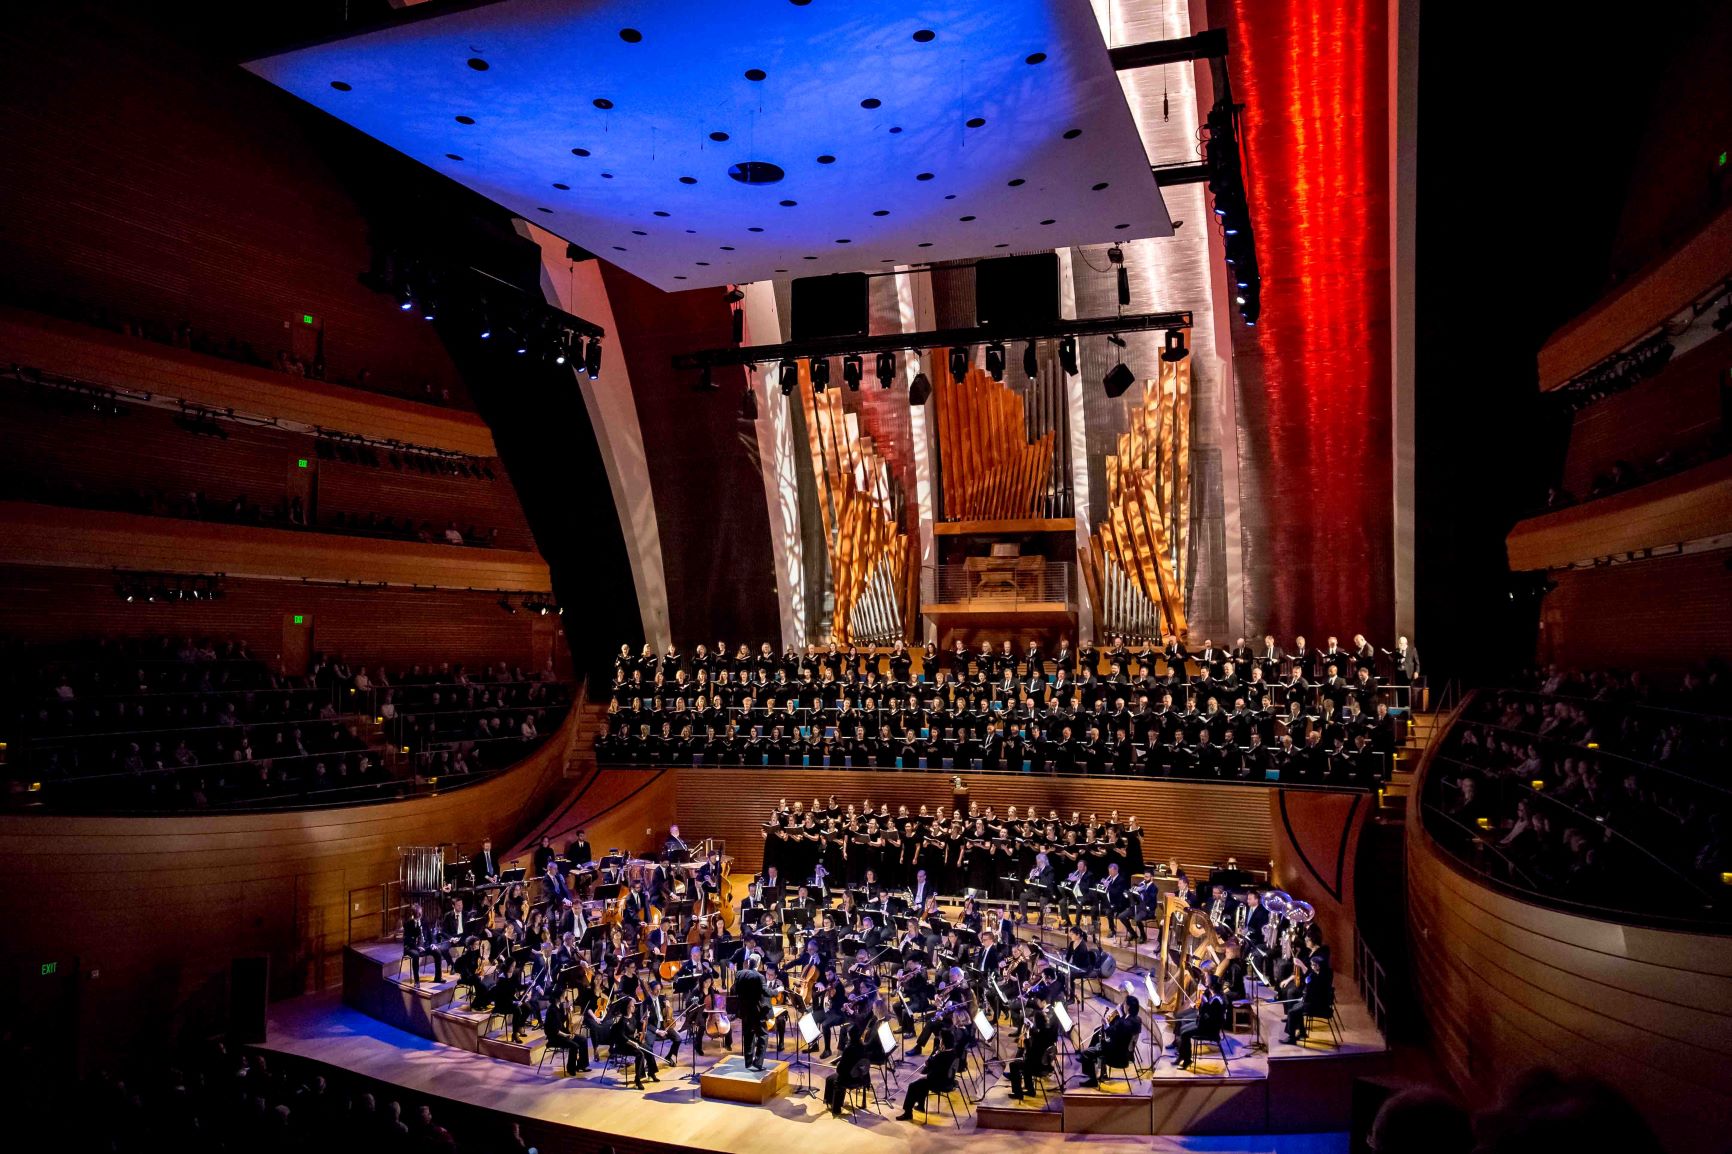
top-left (0, 501), bottom-right (551, 591)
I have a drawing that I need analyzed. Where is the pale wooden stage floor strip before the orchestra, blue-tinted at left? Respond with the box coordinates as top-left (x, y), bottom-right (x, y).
top-left (260, 991), bottom-right (1347, 1154)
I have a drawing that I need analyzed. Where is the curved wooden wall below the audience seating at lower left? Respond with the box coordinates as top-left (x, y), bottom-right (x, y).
top-left (0, 710), bottom-right (580, 1054)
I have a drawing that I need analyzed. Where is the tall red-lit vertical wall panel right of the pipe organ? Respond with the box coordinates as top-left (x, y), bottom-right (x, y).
top-left (1211, 0), bottom-right (1394, 643)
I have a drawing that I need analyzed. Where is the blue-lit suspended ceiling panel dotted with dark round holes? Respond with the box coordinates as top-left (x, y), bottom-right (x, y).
top-left (248, 0), bottom-right (1173, 289)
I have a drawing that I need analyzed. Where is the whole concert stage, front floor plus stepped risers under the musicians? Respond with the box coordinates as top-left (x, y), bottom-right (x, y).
top-left (262, 943), bottom-right (1387, 1154)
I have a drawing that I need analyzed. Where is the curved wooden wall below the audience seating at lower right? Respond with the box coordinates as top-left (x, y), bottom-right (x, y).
top-left (1406, 738), bottom-right (1732, 1151)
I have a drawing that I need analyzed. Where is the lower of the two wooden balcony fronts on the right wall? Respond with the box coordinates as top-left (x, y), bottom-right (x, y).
top-left (1505, 457), bottom-right (1732, 570)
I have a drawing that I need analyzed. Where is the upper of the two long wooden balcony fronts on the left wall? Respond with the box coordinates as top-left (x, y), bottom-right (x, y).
top-left (0, 315), bottom-right (497, 457)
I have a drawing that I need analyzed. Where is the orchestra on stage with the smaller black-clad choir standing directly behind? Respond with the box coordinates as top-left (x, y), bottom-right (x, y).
top-left (402, 803), bottom-right (1334, 1118)
